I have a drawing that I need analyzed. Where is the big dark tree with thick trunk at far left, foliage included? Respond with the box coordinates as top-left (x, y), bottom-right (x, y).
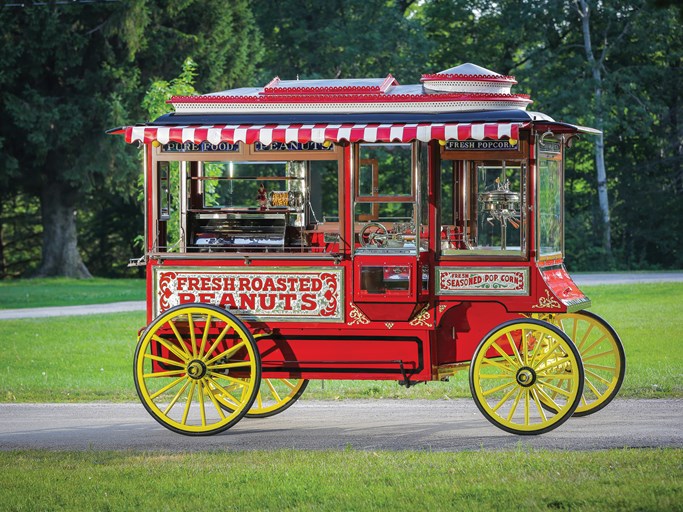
top-left (0, 1), bottom-right (145, 277)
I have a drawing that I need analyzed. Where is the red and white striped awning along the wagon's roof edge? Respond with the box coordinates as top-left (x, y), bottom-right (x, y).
top-left (113, 123), bottom-right (523, 145)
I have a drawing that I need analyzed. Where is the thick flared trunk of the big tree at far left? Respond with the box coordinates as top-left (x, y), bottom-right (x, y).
top-left (35, 180), bottom-right (92, 278)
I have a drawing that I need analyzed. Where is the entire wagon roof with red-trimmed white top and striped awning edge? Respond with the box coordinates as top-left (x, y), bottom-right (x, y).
top-left (110, 63), bottom-right (600, 144)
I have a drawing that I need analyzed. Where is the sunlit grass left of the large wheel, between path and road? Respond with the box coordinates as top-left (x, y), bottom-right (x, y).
top-left (0, 312), bottom-right (145, 402)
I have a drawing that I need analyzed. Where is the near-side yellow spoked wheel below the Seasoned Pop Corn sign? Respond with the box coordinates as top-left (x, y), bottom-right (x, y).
top-left (470, 319), bottom-right (584, 435)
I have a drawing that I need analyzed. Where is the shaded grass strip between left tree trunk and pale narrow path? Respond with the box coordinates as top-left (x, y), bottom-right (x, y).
top-left (0, 278), bottom-right (145, 309)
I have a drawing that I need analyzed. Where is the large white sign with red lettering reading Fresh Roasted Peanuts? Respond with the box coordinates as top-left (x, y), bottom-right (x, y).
top-left (155, 268), bottom-right (343, 321)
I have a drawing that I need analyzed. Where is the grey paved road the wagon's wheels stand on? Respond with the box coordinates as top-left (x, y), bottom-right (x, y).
top-left (0, 399), bottom-right (683, 452)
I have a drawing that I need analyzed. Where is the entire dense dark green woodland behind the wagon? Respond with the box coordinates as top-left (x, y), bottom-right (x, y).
top-left (0, 0), bottom-right (683, 278)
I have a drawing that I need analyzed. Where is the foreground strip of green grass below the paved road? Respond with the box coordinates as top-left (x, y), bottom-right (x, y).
top-left (0, 449), bottom-right (683, 511)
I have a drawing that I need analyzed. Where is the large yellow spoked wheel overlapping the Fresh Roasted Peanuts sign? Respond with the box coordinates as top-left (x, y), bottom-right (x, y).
top-left (134, 304), bottom-right (261, 436)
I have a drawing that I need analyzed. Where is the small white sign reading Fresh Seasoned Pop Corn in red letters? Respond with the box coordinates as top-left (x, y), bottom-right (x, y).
top-left (436, 268), bottom-right (529, 295)
